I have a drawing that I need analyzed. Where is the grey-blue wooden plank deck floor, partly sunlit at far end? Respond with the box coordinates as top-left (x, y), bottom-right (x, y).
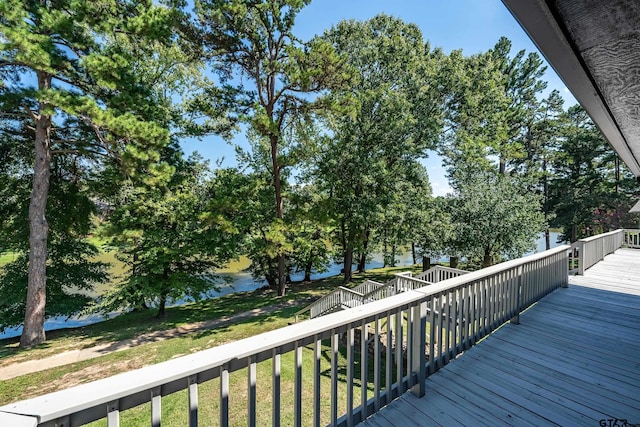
top-left (361, 249), bottom-right (640, 427)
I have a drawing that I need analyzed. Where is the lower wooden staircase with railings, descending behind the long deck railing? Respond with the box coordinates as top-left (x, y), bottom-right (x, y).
top-left (295, 265), bottom-right (468, 322)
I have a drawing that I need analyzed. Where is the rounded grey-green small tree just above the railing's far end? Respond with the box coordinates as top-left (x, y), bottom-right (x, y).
top-left (451, 170), bottom-right (544, 267)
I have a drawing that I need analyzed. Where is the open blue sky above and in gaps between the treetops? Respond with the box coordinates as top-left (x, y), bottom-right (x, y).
top-left (183, 0), bottom-right (576, 195)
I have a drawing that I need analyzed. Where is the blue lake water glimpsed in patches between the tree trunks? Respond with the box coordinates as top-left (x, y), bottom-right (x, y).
top-left (0, 232), bottom-right (561, 339)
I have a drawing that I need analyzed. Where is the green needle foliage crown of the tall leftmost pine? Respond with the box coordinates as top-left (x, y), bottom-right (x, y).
top-left (0, 0), bottom-right (175, 160)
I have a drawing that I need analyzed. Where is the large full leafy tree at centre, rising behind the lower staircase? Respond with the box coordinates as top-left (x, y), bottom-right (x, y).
top-left (310, 15), bottom-right (445, 283)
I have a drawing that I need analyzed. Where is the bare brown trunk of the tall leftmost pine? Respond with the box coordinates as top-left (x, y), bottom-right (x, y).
top-left (20, 71), bottom-right (51, 347)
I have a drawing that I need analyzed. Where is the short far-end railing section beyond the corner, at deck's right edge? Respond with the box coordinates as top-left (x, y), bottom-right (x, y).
top-left (569, 230), bottom-right (625, 275)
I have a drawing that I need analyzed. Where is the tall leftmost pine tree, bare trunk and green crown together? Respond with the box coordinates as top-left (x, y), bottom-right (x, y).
top-left (0, 0), bottom-right (176, 346)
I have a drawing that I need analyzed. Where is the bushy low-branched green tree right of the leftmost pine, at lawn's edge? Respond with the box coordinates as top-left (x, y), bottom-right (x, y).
top-left (96, 152), bottom-right (237, 316)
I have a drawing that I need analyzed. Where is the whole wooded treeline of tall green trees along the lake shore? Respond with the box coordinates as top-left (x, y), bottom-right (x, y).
top-left (0, 0), bottom-right (637, 346)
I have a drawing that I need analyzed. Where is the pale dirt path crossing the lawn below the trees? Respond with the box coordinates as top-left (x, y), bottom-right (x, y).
top-left (0, 299), bottom-right (309, 381)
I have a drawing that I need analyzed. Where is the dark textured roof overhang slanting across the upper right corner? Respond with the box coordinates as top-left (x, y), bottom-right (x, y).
top-left (502, 0), bottom-right (640, 180)
